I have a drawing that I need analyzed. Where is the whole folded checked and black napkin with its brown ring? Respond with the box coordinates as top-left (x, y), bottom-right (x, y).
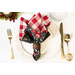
top-left (19, 13), bottom-right (51, 60)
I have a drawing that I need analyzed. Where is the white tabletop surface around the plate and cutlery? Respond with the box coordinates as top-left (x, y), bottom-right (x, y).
top-left (0, 12), bottom-right (75, 63)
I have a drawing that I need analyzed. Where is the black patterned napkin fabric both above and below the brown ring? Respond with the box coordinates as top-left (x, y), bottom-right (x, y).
top-left (22, 26), bottom-right (50, 61)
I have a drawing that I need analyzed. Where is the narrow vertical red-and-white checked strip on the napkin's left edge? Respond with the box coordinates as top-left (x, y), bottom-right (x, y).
top-left (19, 17), bottom-right (28, 40)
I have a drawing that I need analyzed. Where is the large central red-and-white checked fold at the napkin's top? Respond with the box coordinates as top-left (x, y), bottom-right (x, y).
top-left (28, 13), bottom-right (42, 32)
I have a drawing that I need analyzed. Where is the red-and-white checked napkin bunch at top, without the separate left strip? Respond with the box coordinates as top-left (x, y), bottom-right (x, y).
top-left (28, 13), bottom-right (51, 32)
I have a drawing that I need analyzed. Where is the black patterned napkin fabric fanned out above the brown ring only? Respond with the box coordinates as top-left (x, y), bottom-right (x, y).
top-left (22, 26), bottom-right (50, 43)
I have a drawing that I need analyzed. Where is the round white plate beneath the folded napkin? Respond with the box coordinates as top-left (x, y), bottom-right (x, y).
top-left (15, 13), bottom-right (60, 61)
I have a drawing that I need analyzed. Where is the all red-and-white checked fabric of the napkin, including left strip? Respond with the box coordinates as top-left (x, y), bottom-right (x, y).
top-left (19, 13), bottom-right (51, 40)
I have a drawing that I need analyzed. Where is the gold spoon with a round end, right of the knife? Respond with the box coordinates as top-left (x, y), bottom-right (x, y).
top-left (64, 34), bottom-right (73, 61)
